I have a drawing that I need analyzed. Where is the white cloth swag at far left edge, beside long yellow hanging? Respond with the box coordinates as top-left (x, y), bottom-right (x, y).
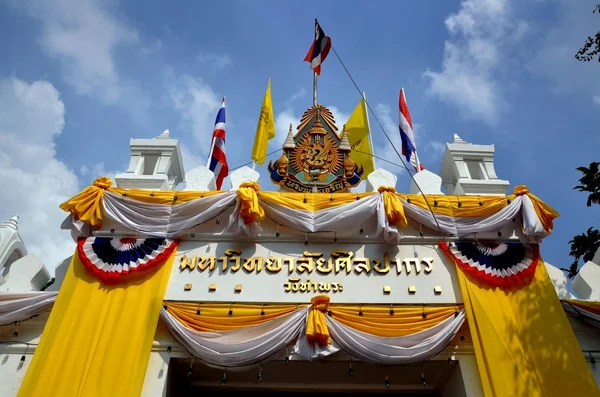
top-left (0, 291), bottom-right (57, 325)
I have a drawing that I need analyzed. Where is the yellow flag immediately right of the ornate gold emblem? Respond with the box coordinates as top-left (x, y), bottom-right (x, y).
top-left (346, 98), bottom-right (375, 179)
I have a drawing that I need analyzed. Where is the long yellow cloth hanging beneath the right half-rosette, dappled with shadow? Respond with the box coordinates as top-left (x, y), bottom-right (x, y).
top-left (457, 261), bottom-right (600, 397)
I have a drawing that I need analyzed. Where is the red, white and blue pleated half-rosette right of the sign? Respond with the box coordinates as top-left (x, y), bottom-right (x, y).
top-left (440, 241), bottom-right (540, 289)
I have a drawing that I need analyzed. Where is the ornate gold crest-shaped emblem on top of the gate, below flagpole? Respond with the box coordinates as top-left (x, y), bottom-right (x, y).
top-left (269, 105), bottom-right (363, 193)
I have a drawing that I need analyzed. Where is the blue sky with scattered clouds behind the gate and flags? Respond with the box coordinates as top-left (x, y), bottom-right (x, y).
top-left (0, 0), bottom-right (600, 267)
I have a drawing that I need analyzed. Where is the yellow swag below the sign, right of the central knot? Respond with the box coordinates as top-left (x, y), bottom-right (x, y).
top-left (329, 305), bottom-right (462, 338)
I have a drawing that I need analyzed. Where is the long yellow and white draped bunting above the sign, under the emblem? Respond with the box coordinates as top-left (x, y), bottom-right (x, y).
top-left (61, 178), bottom-right (558, 242)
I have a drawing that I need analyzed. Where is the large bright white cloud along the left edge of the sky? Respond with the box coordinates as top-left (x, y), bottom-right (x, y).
top-left (0, 79), bottom-right (80, 269)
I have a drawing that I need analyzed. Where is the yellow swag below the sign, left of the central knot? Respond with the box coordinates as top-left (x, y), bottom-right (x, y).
top-left (165, 302), bottom-right (302, 332)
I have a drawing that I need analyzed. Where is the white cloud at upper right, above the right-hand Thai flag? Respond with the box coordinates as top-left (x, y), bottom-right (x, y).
top-left (424, 0), bottom-right (529, 123)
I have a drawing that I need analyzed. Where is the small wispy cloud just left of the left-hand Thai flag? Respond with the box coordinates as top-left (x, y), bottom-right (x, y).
top-left (169, 76), bottom-right (221, 153)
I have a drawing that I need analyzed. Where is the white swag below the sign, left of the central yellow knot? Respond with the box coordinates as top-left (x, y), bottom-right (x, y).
top-left (161, 308), bottom-right (308, 368)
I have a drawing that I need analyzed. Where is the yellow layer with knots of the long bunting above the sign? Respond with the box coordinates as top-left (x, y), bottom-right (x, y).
top-left (60, 181), bottom-right (558, 233)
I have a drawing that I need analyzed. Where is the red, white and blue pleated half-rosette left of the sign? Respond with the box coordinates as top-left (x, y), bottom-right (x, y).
top-left (77, 237), bottom-right (177, 282)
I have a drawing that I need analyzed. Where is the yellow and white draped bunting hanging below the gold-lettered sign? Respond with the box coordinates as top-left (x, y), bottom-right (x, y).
top-left (161, 298), bottom-right (465, 369)
